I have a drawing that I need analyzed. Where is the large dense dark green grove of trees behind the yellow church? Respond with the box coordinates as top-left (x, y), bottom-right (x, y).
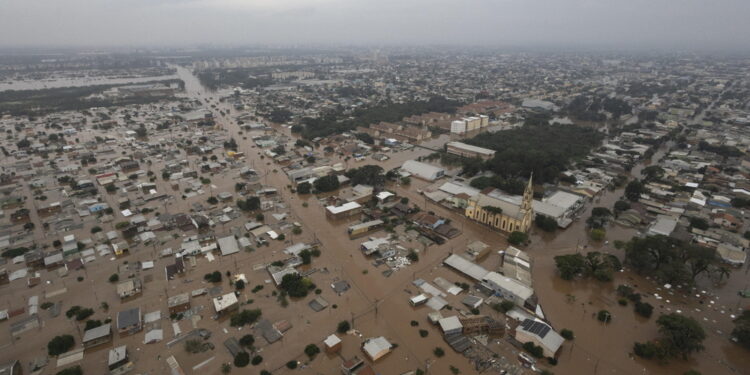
top-left (468, 124), bottom-right (602, 183)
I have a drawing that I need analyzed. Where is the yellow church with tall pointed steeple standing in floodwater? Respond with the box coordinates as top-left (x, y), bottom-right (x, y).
top-left (465, 176), bottom-right (534, 233)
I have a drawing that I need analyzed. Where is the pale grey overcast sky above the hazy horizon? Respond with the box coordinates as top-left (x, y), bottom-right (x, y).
top-left (0, 0), bottom-right (750, 50)
